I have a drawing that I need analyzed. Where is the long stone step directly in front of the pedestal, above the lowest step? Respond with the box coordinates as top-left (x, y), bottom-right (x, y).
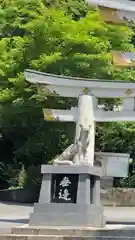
top-left (11, 225), bottom-right (135, 239)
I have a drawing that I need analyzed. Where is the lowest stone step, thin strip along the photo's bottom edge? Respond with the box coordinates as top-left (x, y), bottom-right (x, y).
top-left (0, 234), bottom-right (135, 240)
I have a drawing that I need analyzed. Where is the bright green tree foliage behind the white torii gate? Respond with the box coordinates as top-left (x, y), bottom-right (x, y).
top-left (0, 0), bottom-right (135, 188)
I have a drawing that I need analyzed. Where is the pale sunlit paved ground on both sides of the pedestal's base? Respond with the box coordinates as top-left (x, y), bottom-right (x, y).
top-left (0, 203), bottom-right (135, 233)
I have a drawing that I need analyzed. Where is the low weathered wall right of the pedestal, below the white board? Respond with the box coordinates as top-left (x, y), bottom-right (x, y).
top-left (101, 188), bottom-right (135, 206)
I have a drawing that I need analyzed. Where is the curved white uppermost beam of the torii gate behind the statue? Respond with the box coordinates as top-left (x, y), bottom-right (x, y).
top-left (25, 70), bottom-right (135, 98)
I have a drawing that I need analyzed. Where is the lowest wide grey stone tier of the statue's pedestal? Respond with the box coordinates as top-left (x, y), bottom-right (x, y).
top-left (29, 212), bottom-right (105, 228)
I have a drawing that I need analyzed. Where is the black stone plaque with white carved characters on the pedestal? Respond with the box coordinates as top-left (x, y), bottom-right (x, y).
top-left (51, 174), bottom-right (79, 203)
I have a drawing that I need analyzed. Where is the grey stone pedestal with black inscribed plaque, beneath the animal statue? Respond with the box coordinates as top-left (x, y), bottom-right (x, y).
top-left (29, 165), bottom-right (105, 227)
